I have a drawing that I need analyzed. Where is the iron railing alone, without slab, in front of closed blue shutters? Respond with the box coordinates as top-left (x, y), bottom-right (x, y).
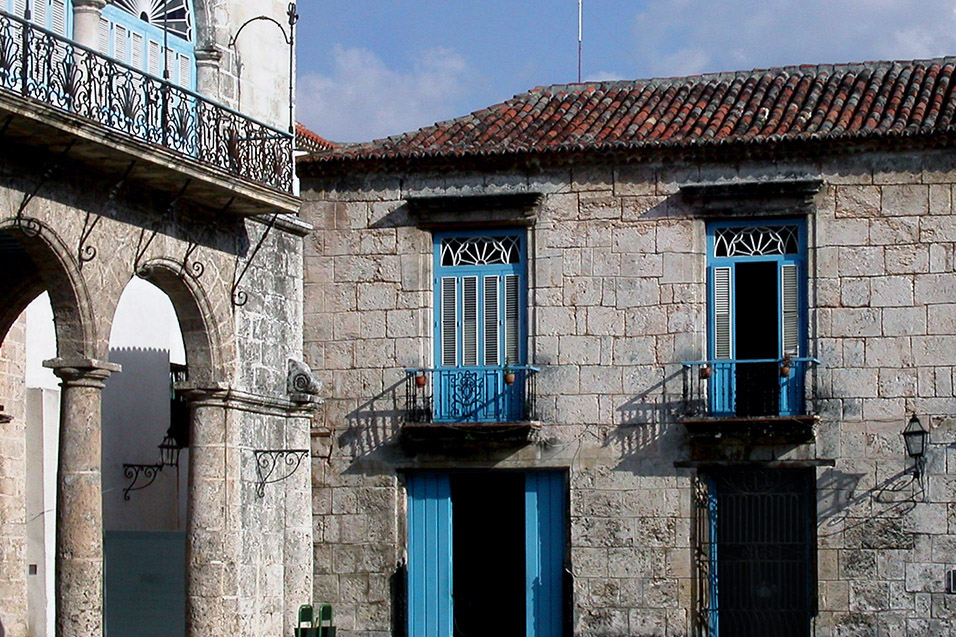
top-left (405, 365), bottom-right (538, 423)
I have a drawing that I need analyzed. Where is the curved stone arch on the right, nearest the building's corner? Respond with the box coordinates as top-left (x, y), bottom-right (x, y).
top-left (137, 258), bottom-right (228, 384)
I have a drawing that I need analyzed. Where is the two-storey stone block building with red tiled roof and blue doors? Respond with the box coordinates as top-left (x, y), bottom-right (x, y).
top-left (299, 58), bottom-right (956, 637)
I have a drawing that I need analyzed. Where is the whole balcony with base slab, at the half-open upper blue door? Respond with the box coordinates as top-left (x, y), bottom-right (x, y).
top-left (681, 356), bottom-right (820, 439)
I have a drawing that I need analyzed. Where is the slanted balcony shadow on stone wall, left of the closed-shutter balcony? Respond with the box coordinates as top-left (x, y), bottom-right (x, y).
top-left (338, 379), bottom-right (405, 458)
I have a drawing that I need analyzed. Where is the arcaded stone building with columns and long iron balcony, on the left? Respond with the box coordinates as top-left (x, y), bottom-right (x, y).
top-left (0, 0), bottom-right (315, 637)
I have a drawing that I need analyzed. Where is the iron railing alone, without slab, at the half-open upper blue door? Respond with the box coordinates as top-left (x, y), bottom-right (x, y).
top-left (682, 357), bottom-right (820, 418)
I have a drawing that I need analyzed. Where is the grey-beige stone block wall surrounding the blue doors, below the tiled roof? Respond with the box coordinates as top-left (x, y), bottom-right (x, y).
top-left (303, 147), bottom-right (956, 636)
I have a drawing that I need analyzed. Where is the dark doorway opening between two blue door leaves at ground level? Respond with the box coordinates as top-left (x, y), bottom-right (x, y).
top-left (451, 472), bottom-right (526, 637)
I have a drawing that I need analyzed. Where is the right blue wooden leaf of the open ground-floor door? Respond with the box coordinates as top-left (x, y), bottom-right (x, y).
top-left (525, 471), bottom-right (567, 637)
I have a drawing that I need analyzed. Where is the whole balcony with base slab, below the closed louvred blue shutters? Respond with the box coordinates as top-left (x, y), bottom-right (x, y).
top-left (403, 365), bottom-right (538, 444)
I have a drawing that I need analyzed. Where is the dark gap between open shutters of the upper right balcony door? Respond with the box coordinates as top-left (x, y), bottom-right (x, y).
top-left (734, 261), bottom-right (780, 417)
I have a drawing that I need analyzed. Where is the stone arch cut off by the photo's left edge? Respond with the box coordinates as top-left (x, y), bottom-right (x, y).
top-left (0, 219), bottom-right (99, 359)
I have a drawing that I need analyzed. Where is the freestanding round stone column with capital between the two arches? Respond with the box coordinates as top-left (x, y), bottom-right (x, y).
top-left (43, 358), bottom-right (120, 637)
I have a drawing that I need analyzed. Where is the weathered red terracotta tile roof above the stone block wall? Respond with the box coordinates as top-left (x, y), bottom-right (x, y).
top-left (303, 57), bottom-right (956, 161)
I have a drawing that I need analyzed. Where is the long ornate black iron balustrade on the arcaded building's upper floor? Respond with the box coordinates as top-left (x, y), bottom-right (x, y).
top-left (0, 11), bottom-right (293, 192)
